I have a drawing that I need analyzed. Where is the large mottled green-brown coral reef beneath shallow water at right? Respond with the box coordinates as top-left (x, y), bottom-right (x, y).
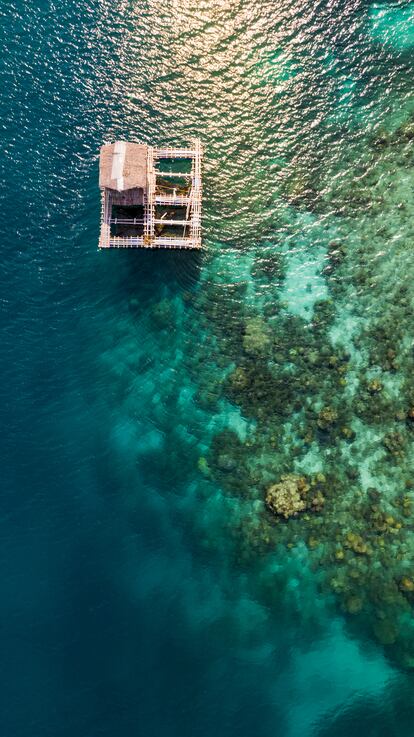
top-left (201, 108), bottom-right (414, 667)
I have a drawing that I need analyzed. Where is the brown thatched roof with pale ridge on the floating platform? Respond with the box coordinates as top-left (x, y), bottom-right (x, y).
top-left (99, 141), bottom-right (147, 192)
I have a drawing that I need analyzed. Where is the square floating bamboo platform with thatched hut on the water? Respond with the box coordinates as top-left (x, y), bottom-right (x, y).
top-left (99, 140), bottom-right (202, 249)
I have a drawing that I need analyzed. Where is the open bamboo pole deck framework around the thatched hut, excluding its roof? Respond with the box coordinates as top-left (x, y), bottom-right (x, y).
top-left (99, 140), bottom-right (202, 249)
